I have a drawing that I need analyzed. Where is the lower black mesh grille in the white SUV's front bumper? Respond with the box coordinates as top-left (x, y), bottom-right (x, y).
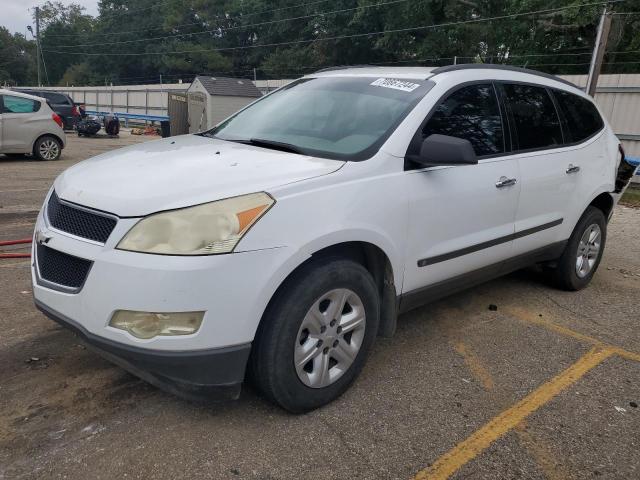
top-left (36, 244), bottom-right (93, 291)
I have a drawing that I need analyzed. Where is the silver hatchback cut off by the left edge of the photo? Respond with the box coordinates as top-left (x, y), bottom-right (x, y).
top-left (0, 89), bottom-right (66, 160)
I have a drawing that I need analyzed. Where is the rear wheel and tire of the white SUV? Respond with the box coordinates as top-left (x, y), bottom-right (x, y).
top-left (551, 206), bottom-right (607, 291)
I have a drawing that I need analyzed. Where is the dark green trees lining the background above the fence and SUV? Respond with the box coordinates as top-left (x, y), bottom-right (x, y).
top-left (5, 0), bottom-right (640, 84)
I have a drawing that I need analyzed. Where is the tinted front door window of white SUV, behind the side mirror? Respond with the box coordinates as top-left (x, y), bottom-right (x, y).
top-left (422, 83), bottom-right (504, 157)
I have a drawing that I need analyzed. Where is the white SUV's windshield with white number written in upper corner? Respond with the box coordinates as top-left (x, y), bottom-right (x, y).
top-left (204, 77), bottom-right (433, 160)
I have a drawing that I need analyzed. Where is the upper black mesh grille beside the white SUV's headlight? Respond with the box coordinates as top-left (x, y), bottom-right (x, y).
top-left (47, 192), bottom-right (117, 243)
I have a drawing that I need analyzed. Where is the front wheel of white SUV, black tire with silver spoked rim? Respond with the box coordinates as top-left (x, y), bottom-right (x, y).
top-left (250, 257), bottom-right (380, 413)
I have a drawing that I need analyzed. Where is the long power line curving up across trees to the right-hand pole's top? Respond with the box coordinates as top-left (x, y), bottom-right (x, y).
top-left (45, 0), bottom-right (624, 56)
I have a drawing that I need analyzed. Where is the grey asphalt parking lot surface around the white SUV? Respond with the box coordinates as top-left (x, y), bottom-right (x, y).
top-left (0, 133), bottom-right (640, 480)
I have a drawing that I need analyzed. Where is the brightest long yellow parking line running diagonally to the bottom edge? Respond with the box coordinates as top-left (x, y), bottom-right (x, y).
top-left (414, 346), bottom-right (617, 480)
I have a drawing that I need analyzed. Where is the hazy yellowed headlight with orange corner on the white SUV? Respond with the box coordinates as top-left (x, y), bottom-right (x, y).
top-left (116, 192), bottom-right (275, 255)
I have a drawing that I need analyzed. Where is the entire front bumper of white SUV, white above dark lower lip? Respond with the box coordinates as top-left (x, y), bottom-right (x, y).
top-left (31, 193), bottom-right (297, 399)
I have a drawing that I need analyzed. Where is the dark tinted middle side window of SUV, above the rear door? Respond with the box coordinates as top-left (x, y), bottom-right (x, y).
top-left (503, 83), bottom-right (563, 150)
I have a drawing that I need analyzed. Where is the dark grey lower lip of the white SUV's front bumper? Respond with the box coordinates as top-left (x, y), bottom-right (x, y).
top-left (35, 300), bottom-right (251, 401)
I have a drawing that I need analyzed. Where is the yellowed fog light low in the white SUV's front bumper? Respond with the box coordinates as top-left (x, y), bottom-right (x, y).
top-left (109, 310), bottom-right (204, 338)
